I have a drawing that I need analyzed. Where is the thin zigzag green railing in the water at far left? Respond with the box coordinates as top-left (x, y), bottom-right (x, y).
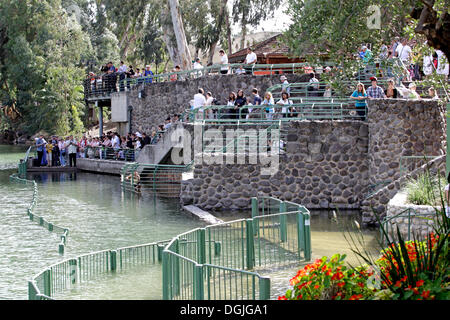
top-left (9, 172), bottom-right (69, 255)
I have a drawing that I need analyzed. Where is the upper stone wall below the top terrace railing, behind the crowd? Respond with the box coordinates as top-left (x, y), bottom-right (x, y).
top-left (126, 74), bottom-right (309, 133)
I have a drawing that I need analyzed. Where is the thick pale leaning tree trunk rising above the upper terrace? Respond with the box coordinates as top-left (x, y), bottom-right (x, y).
top-left (169, 0), bottom-right (192, 70)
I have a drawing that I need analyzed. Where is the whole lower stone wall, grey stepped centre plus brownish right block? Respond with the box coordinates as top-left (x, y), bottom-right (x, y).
top-left (181, 99), bottom-right (445, 224)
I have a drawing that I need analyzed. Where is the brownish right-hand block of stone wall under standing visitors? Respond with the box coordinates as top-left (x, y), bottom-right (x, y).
top-left (368, 99), bottom-right (446, 185)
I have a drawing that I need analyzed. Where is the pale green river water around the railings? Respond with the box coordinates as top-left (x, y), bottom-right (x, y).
top-left (0, 145), bottom-right (377, 300)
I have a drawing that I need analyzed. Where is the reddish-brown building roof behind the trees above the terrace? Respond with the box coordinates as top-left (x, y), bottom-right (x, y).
top-left (228, 33), bottom-right (289, 60)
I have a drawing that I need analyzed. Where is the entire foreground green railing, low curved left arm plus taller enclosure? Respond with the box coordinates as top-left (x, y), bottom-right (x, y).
top-left (28, 197), bottom-right (311, 300)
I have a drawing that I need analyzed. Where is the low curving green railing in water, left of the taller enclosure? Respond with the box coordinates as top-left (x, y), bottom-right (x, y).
top-left (28, 241), bottom-right (168, 300)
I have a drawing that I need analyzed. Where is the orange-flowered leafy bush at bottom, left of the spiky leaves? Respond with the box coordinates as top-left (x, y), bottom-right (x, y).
top-left (278, 254), bottom-right (374, 300)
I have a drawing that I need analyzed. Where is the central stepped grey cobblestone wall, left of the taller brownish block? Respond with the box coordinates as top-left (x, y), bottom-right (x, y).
top-left (182, 121), bottom-right (369, 210)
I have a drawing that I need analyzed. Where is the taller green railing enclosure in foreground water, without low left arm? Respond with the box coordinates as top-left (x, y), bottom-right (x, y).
top-left (162, 197), bottom-right (311, 300)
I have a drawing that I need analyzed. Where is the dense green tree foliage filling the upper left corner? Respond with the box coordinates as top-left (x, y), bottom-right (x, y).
top-left (0, 0), bottom-right (92, 135)
